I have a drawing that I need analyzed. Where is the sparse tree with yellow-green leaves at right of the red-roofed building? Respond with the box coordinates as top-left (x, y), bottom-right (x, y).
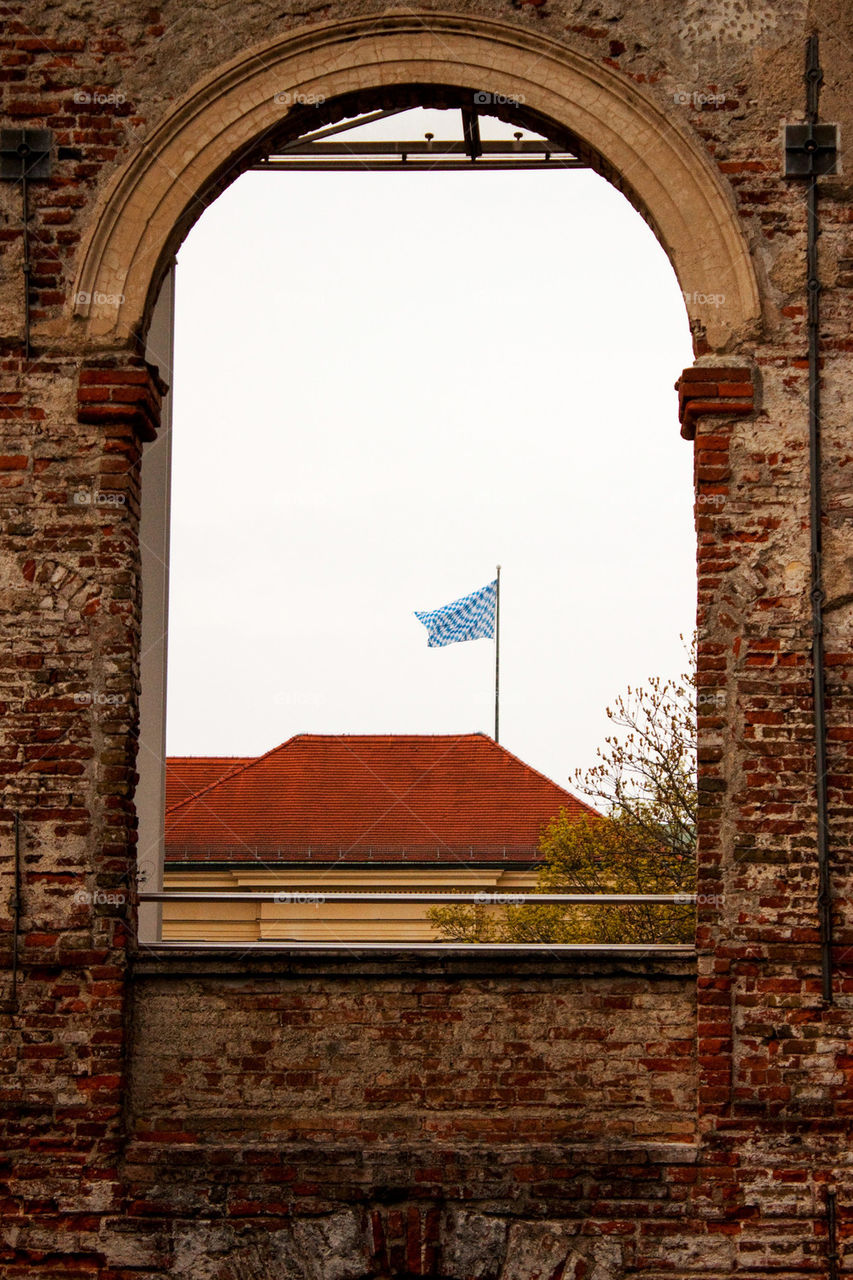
top-left (429, 653), bottom-right (697, 942)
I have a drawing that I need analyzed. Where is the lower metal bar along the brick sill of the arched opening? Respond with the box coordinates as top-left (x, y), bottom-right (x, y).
top-left (142, 940), bottom-right (695, 956)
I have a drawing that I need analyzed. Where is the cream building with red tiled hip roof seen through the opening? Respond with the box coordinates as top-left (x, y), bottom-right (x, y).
top-left (163, 733), bottom-right (597, 943)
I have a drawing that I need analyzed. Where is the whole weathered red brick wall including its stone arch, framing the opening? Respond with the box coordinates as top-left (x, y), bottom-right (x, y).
top-left (0, 0), bottom-right (853, 1280)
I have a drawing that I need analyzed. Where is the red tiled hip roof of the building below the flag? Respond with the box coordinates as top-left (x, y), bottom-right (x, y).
top-left (167, 733), bottom-right (596, 863)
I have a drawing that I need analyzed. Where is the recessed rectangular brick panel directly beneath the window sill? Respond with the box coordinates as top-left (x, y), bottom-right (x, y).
top-left (131, 959), bottom-right (695, 1146)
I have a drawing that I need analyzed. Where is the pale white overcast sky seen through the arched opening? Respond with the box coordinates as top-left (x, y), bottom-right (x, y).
top-left (162, 111), bottom-right (695, 785)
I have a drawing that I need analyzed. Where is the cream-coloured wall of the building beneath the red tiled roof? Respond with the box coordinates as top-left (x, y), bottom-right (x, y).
top-left (163, 867), bottom-right (535, 942)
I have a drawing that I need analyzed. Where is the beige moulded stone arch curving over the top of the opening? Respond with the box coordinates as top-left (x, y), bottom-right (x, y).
top-left (73, 13), bottom-right (760, 353)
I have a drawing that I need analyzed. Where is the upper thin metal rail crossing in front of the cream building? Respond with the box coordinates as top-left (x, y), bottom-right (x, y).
top-left (140, 887), bottom-right (695, 906)
